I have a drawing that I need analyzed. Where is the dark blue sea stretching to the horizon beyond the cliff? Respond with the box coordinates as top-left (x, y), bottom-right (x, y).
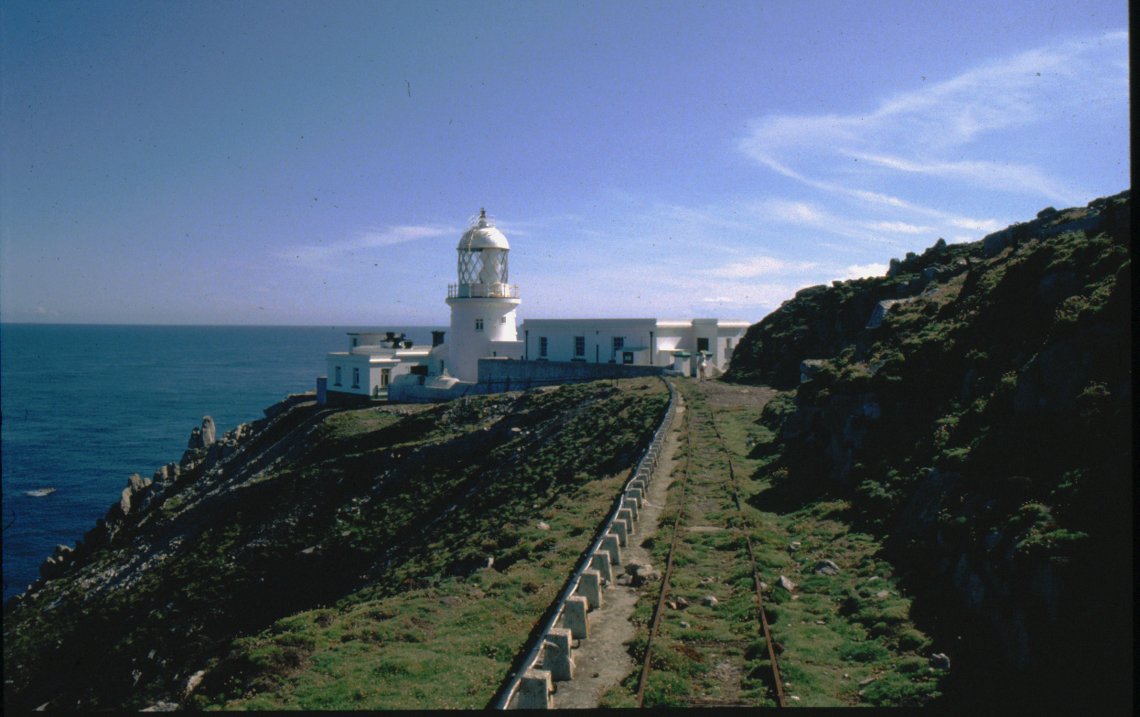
top-left (0, 324), bottom-right (445, 601)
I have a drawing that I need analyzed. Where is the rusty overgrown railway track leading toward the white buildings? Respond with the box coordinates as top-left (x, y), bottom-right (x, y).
top-left (636, 383), bottom-right (787, 708)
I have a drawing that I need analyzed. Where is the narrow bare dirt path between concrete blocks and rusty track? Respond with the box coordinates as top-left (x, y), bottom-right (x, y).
top-left (552, 393), bottom-right (685, 709)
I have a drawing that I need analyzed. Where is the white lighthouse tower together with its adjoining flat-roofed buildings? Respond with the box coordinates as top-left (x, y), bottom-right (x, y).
top-left (318, 211), bottom-right (749, 402)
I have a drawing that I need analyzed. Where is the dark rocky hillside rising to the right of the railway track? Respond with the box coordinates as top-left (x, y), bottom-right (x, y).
top-left (727, 192), bottom-right (1132, 708)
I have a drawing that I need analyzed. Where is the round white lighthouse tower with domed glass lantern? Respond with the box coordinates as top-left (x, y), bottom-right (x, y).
top-left (447, 210), bottom-right (521, 382)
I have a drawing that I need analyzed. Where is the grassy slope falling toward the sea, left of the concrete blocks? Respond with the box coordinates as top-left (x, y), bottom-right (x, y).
top-left (3, 378), bottom-right (668, 711)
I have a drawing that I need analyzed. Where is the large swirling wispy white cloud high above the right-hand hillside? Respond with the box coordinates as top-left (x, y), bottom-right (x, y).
top-left (740, 32), bottom-right (1129, 234)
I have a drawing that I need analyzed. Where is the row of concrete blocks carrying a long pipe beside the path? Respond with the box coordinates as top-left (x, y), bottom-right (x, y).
top-left (511, 386), bottom-right (675, 709)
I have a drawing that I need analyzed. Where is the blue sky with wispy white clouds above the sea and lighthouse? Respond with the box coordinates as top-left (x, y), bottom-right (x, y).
top-left (0, 0), bottom-right (1130, 326)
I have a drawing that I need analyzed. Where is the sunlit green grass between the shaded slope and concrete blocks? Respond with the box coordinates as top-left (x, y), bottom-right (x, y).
top-left (190, 378), bottom-right (663, 709)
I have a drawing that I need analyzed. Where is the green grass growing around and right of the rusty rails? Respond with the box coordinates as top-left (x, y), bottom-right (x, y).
top-left (603, 382), bottom-right (942, 707)
